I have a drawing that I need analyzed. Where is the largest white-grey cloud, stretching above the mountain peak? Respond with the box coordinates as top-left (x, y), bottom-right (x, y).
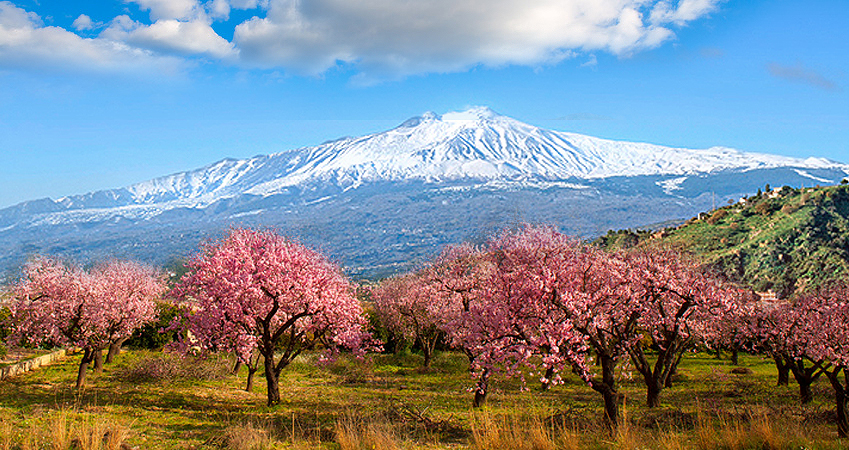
top-left (234, 0), bottom-right (720, 76)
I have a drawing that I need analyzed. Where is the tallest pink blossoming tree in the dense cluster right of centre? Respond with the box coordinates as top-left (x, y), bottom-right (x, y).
top-left (474, 225), bottom-right (641, 427)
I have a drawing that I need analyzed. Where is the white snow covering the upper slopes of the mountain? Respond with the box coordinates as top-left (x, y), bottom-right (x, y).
top-left (13, 107), bottom-right (849, 222)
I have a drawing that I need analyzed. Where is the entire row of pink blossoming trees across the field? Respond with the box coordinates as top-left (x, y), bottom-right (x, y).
top-left (1, 225), bottom-right (849, 437)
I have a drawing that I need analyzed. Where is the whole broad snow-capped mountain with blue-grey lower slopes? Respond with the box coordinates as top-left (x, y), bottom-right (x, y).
top-left (0, 108), bottom-right (849, 277)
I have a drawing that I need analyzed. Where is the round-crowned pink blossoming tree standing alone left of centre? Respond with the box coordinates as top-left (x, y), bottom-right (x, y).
top-left (178, 229), bottom-right (369, 406)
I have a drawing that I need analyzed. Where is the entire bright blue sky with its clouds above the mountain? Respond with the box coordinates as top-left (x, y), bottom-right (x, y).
top-left (0, 0), bottom-right (849, 207)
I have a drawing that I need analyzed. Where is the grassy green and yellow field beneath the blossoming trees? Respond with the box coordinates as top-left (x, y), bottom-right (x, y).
top-left (0, 351), bottom-right (849, 449)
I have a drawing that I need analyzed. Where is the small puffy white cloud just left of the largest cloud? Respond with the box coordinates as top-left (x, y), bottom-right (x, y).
top-left (106, 16), bottom-right (237, 60)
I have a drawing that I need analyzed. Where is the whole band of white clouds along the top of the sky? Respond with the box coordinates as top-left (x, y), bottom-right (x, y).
top-left (0, 0), bottom-right (722, 78)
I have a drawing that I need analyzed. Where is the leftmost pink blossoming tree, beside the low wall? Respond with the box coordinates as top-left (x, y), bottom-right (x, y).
top-left (10, 258), bottom-right (165, 388)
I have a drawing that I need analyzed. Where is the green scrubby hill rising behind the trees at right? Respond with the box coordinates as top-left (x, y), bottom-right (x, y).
top-left (598, 180), bottom-right (849, 298)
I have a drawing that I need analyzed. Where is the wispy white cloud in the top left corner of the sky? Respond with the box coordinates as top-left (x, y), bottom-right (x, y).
top-left (0, 1), bottom-right (183, 74)
